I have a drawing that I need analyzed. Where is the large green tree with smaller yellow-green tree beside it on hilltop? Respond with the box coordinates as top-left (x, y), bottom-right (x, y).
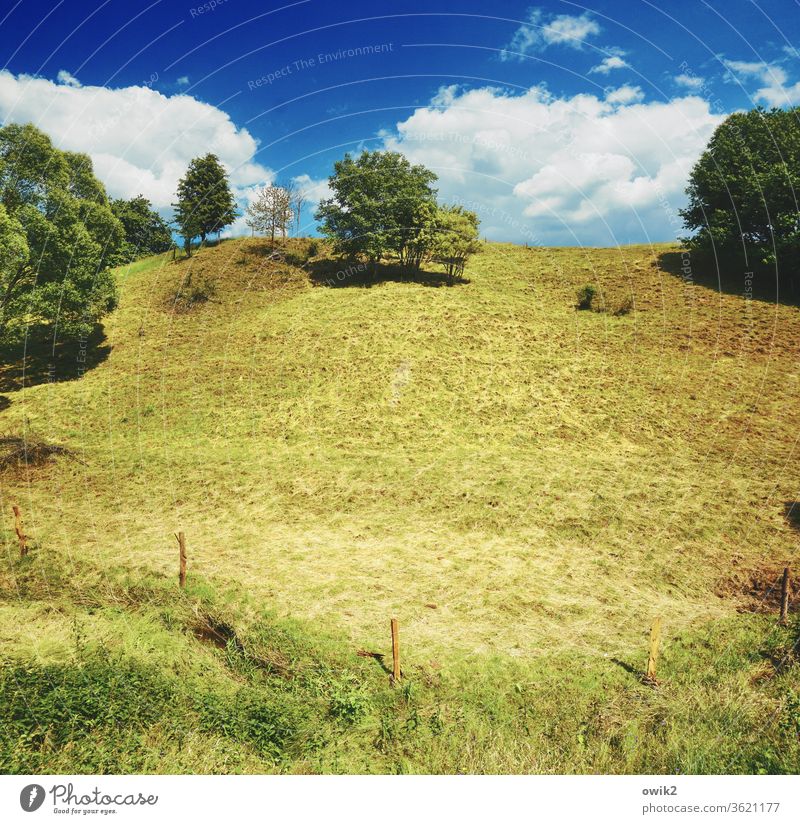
top-left (315, 151), bottom-right (480, 282)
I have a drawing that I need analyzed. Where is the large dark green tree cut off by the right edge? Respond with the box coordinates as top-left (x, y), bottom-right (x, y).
top-left (681, 107), bottom-right (800, 286)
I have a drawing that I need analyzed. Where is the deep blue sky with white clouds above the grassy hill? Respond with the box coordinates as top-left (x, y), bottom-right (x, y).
top-left (0, 0), bottom-right (800, 246)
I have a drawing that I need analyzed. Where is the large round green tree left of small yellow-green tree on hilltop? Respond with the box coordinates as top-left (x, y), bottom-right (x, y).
top-left (315, 151), bottom-right (436, 268)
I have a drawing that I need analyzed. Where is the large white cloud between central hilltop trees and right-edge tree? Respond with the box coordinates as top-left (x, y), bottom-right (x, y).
top-left (383, 86), bottom-right (723, 245)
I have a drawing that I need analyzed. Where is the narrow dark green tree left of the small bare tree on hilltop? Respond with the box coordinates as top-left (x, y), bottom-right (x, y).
top-left (172, 154), bottom-right (237, 254)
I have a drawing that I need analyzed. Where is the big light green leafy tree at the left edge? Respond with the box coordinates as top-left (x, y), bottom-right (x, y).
top-left (0, 124), bottom-right (124, 342)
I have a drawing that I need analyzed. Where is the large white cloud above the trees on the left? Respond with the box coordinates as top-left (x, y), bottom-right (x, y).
top-left (0, 71), bottom-right (272, 211)
